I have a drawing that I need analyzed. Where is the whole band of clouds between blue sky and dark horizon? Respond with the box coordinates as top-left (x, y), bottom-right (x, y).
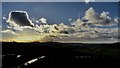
top-left (1, 7), bottom-right (118, 42)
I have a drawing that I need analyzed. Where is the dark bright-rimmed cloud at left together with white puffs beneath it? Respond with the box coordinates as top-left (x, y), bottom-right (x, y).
top-left (6, 11), bottom-right (34, 31)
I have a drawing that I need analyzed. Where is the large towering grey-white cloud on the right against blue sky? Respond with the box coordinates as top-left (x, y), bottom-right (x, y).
top-left (82, 7), bottom-right (117, 26)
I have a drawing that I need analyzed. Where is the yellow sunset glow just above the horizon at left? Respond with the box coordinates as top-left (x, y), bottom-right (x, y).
top-left (2, 33), bottom-right (61, 42)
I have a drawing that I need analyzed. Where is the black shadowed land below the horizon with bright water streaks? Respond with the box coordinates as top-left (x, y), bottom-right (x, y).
top-left (2, 42), bottom-right (120, 68)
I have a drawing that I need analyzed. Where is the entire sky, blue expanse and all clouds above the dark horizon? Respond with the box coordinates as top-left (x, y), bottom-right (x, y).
top-left (1, 2), bottom-right (118, 42)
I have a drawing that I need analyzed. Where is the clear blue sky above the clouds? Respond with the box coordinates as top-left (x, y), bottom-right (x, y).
top-left (2, 2), bottom-right (118, 29)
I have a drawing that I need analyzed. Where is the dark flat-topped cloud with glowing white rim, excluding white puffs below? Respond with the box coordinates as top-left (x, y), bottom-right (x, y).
top-left (7, 11), bottom-right (34, 26)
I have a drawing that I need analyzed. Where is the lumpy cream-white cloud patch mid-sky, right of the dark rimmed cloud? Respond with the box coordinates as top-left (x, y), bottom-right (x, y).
top-left (34, 23), bottom-right (69, 33)
